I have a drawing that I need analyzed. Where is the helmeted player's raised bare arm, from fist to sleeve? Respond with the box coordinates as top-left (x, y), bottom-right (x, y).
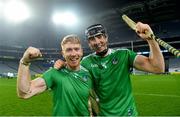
top-left (134, 23), bottom-right (165, 73)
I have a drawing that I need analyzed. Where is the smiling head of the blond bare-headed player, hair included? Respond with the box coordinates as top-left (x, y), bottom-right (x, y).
top-left (61, 34), bottom-right (83, 70)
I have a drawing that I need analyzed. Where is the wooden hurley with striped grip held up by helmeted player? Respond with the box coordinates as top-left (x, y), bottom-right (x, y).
top-left (122, 15), bottom-right (180, 57)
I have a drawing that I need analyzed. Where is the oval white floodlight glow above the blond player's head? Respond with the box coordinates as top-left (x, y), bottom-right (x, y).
top-left (52, 12), bottom-right (78, 26)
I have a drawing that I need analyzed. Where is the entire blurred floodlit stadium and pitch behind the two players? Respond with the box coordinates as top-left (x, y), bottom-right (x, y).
top-left (0, 0), bottom-right (180, 116)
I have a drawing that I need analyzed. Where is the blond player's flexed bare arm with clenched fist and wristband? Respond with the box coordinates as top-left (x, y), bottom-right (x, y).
top-left (17, 47), bottom-right (47, 99)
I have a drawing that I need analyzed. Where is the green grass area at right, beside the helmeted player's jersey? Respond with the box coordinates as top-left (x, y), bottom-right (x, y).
top-left (132, 75), bottom-right (180, 116)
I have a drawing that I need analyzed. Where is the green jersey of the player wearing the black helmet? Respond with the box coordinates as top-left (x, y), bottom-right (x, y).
top-left (81, 49), bottom-right (137, 116)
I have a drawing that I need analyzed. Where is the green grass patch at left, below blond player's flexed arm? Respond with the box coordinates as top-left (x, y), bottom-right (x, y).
top-left (0, 78), bottom-right (52, 116)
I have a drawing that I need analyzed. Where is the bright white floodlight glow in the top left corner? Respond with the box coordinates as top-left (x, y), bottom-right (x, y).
top-left (4, 0), bottom-right (30, 23)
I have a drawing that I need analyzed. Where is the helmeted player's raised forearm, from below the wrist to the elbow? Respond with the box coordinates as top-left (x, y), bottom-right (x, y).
top-left (148, 40), bottom-right (164, 72)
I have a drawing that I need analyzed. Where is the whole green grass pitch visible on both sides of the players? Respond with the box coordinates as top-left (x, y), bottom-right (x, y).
top-left (0, 75), bottom-right (180, 116)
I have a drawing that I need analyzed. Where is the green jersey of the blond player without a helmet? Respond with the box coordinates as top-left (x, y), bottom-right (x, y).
top-left (43, 66), bottom-right (91, 116)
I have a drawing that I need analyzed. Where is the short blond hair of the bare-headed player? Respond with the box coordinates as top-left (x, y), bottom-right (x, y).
top-left (61, 34), bottom-right (81, 49)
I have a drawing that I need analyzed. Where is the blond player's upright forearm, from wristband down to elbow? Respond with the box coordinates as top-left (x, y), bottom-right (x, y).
top-left (17, 59), bottom-right (31, 97)
